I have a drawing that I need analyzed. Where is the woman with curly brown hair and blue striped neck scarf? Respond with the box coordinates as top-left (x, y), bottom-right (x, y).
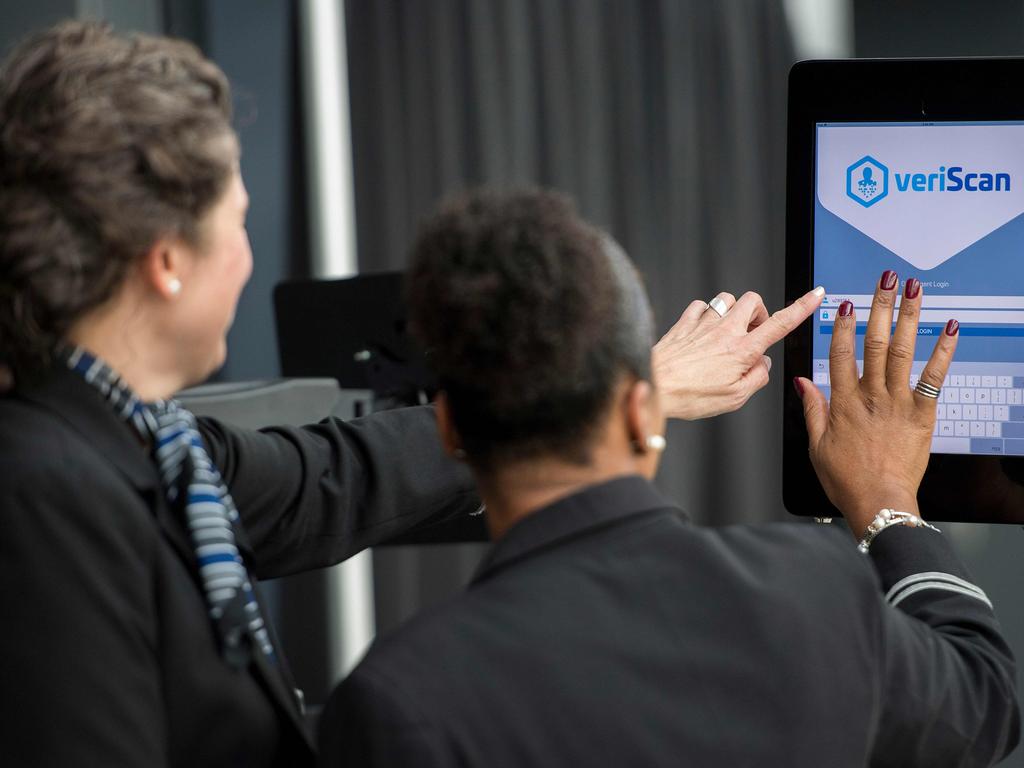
top-left (0, 23), bottom-right (479, 767)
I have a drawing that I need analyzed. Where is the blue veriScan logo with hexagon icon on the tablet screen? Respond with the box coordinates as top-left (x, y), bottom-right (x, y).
top-left (846, 155), bottom-right (1012, 208)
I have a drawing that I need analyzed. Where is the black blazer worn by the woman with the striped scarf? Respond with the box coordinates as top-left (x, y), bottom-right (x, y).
top-left (0, 371), bottom-right (478, 768)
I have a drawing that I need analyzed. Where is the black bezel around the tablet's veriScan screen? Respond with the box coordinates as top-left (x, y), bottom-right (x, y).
top-left (782, 57), bottom-right (1024, 523)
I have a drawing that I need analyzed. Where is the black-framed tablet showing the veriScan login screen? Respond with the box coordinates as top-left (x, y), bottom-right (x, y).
top-left (783, 58), bottom-right (1024, 522)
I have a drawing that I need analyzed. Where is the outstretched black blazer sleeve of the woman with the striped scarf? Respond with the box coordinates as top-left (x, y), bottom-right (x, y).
top-left (200, 407), bottom-right (480, 579)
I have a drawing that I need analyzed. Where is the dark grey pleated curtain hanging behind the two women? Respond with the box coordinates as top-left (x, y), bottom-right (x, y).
top-left (346, 0), bottom-right (793, 626)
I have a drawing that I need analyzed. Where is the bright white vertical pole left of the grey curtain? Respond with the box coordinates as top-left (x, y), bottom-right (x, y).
top-left (299, 0), bottom-right (376, 682)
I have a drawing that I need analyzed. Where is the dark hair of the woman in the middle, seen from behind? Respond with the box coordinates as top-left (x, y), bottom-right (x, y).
top-left (408, 190), bottom-right (653, 470)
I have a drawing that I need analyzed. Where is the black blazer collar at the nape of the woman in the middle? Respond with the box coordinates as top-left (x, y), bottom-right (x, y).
top-left (473, 475), bottom-right (686, 583)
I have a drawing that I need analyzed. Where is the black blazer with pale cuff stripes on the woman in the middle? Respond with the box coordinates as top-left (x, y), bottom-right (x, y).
top-left (321, 477), bottom-right (1019, 768)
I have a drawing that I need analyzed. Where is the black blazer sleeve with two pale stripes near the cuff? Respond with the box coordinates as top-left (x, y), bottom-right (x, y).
top-left (870, 526), bottom-right (1020, 768)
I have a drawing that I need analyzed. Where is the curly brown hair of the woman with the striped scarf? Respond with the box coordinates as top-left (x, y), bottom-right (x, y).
top-left (0, 22), bottom-right (238, 378)
